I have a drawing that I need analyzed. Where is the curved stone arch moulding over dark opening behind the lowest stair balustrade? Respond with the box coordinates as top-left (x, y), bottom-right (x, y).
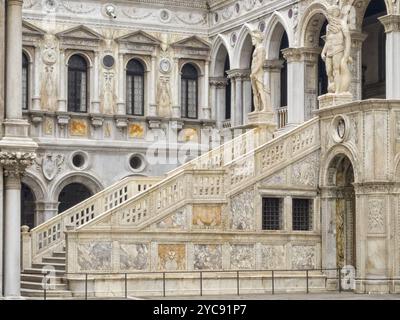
top-left (50, 172), bottom-right (104, 202)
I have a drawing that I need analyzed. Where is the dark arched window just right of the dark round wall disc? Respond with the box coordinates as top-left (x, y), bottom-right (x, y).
top-left (126, 59), bottom-right (144, 116)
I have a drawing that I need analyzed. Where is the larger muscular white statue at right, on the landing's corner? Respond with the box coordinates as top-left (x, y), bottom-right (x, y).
top-left (321, 5), bottom-right (352, 94)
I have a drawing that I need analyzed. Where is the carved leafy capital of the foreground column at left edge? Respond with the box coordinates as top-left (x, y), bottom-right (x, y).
top-left (0, 151), bottom-right (36, 178)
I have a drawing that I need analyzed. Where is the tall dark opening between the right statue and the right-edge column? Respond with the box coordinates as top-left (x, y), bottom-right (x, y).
top-left (362, 0), bottom-right (387, 99)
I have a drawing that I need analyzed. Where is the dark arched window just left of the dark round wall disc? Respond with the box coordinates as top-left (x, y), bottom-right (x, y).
top-left (68, 55), bottom-right (88, 112)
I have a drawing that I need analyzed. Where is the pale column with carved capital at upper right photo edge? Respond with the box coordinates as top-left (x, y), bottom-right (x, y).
top-left (379, 15), bottom-right (400, 99)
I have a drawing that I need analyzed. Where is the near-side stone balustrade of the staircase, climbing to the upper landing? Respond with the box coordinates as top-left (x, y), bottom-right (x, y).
top-left (77, 118), bottom-right (319, 231)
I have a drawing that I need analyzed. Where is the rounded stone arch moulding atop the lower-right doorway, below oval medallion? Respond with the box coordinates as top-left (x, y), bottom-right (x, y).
top-left (320, 144), bottom-right (361, 187)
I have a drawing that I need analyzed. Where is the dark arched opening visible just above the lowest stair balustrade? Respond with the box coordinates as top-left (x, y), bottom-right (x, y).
top-left (58, 182), bottom-right (93, 213)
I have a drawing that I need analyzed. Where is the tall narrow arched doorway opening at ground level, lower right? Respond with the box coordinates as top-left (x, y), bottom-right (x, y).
top-left (328, 154), bottom-right (356, 268)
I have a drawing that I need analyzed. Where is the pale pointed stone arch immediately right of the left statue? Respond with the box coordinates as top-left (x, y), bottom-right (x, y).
top-left (265, 12), bottom-right (293, 60)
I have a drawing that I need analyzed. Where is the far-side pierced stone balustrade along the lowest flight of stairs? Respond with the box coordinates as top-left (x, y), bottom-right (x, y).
top-left (31, 176), bottom-right (161, 259)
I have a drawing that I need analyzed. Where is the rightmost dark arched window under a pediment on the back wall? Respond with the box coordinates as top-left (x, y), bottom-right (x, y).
top-left (181, 64), bottom-right (198, 119)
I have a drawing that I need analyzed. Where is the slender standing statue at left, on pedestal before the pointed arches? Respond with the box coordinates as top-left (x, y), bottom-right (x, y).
top-left (250, 31), bottom-right (272, 112)
